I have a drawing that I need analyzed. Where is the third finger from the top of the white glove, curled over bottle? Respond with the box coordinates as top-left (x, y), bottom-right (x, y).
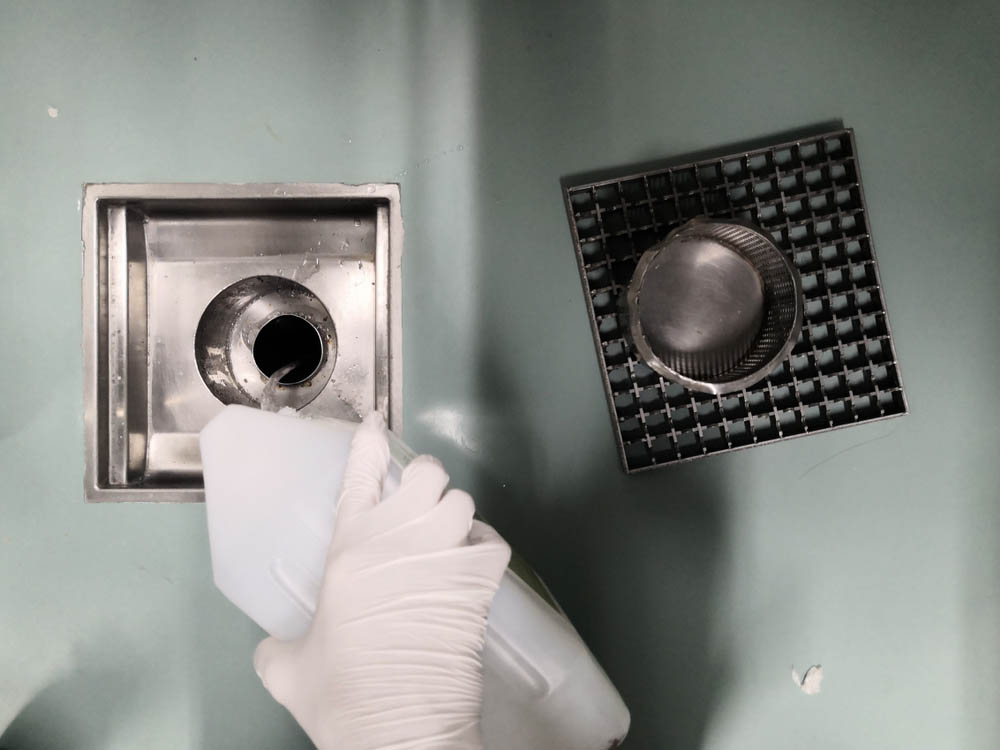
top-left (358, 490), bottom-right (476, 559)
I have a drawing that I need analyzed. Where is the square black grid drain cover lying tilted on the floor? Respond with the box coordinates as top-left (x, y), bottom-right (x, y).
top-left (566, 129), bottom-right (907, 472)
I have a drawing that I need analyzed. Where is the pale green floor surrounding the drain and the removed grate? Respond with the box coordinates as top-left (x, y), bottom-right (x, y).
top-left (0, 0), bottom-right (1000, 750)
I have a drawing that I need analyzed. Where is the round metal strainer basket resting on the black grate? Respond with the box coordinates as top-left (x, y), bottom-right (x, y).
top-left (627, 218), bottom-right (803, 393)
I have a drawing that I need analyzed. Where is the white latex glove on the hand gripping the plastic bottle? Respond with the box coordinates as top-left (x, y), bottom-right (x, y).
top-left (254, 414), bottom-right (510, 750)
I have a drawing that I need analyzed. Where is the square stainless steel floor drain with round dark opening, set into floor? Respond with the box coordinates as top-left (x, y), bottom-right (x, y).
top-left (83, 184), bottom-right (403, 502)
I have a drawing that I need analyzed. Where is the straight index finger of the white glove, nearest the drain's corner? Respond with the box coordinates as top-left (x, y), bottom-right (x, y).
top-left (334, 412), bottom-right (389, 534)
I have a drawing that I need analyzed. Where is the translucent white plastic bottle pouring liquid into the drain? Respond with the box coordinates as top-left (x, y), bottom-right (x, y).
top-left (201, 406), bottom-right (629, 750)
